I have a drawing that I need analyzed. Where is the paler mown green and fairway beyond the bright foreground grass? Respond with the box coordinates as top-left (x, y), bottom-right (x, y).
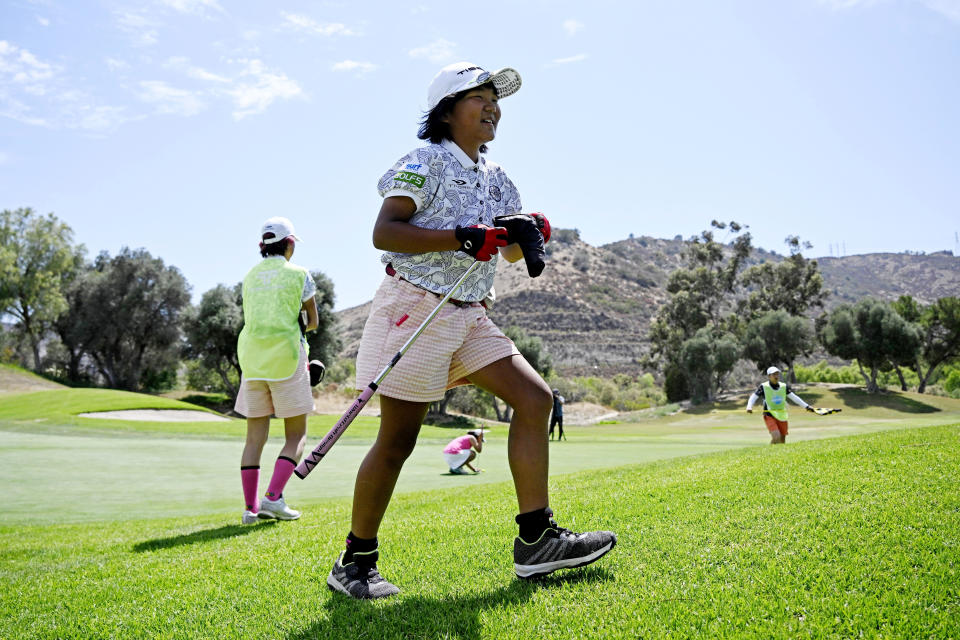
top-left (0, 387), bottom-right (960, 524)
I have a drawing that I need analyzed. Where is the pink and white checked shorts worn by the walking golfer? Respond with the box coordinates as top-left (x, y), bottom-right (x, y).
top-left (357, 276), bottom-right (520, 402)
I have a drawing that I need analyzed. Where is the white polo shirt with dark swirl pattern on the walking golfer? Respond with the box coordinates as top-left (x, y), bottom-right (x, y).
top-left (377, 140), bottom-right (521, 302)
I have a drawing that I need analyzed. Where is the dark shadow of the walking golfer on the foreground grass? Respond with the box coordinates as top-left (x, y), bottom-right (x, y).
top-left (288, 567), bottom-right (614, 640)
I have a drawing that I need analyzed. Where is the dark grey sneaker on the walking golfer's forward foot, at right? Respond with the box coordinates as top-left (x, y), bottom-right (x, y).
top-left (513, 518), bottom-right (617, 579)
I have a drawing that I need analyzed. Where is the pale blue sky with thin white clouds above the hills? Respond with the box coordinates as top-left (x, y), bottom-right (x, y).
top-left (0, 0), bottom-right (960, 308)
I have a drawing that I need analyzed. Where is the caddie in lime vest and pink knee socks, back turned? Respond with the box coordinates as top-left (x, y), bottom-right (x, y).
top-left (234, 217), bottom-right (318, 524)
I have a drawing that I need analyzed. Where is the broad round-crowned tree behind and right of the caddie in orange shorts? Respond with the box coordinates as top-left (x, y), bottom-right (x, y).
top-left (818, 298), bottom-right (920, 393)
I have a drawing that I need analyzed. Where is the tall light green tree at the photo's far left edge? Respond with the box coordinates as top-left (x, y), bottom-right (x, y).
top-left (0, 208), bottom-right (85, 371)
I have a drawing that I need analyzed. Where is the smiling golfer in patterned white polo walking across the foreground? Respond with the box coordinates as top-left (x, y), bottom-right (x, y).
top-left (327, 62), bottom-right (616, 598)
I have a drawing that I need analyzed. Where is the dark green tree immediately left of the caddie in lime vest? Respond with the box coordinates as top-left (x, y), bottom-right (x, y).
top-left (183, 284), bottom-right (243, 398)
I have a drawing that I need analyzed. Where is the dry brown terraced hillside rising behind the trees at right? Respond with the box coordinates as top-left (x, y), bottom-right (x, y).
top-left (337, 232), bottom-right (960, 375)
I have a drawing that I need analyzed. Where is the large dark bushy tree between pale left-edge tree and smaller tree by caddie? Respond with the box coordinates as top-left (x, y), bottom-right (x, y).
top-left (86, 247), bottom-right (190, 391)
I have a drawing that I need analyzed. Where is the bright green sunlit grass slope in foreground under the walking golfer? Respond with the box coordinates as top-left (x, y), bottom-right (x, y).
top-left (0, 425), bottom-right (960, 640)
